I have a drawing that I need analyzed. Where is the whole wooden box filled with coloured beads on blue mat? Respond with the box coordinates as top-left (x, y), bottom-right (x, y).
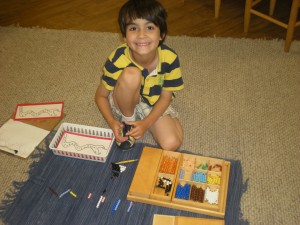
top-left (127, 147), bottom-right (230, 218)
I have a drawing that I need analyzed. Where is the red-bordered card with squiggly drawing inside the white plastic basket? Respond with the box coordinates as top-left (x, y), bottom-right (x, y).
top-left (57, 131), bottom-right (113, 156)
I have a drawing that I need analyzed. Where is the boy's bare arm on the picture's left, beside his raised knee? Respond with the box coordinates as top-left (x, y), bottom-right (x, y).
top-left (95, 82), bottom-right (126, 142)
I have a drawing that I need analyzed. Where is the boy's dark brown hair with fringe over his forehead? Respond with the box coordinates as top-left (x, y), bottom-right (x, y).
top-left (118, 0), bottom-right (168, 44)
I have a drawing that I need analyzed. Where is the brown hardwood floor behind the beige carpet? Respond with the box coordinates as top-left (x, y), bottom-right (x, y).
top-left (0, 0), bottom-right (300, 40)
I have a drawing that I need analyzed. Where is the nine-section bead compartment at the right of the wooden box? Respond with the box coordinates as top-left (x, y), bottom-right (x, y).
top-left (173, 154), bottom-right (224, 207)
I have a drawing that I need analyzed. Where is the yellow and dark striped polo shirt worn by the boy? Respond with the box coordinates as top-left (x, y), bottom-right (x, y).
top-left (102, 44), bottom-right (184, 106)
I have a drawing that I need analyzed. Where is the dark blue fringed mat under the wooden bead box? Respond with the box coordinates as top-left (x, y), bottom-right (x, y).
top-left (1, 133), bottom-right (248, 225)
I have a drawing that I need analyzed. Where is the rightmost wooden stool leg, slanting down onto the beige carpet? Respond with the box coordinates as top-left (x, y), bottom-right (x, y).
top-left (284, 0), bottom-right (300, 52)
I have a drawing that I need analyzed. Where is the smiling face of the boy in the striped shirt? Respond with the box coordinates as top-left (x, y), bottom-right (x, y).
top-left (124, 19), bottom-right (162, 56)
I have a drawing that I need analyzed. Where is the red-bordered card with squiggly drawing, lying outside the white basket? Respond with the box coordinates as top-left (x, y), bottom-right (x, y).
top-left (14, 102), bottom-right (64, 120)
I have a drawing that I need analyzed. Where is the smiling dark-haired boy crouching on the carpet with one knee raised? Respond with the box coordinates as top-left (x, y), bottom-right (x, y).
top-left (95, 0), bottom-right (183, 151)
